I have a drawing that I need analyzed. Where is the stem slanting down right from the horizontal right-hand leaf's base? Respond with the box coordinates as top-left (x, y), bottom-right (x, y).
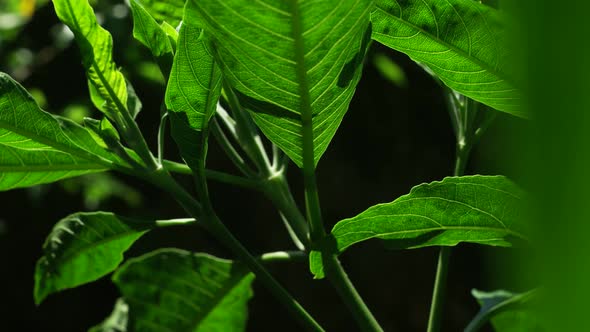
top-left (324, 254), bottom-right (383, 332)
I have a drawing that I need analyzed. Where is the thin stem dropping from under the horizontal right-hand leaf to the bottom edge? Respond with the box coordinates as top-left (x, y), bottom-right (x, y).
top-left (427, 247), bottom-right (451, 332)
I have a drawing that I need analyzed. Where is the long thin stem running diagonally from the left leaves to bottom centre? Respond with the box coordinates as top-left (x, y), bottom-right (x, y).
top-left (145, 170), bottom-right (324, 331)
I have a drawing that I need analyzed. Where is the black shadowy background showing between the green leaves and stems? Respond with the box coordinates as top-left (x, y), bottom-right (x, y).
top-left (0, 1), bottom-right (524, 332)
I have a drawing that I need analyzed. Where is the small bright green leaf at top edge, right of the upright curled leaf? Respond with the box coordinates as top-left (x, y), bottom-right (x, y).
top-left (130, 0), bottom-right (173, 76)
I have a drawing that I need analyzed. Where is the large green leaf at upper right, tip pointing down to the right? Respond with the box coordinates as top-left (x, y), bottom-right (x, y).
top-left (371, 0), bottom-right (525, 117)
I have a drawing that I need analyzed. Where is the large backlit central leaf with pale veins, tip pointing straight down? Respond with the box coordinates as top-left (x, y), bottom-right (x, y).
top-left (186, 0), bottom-right (373, 167)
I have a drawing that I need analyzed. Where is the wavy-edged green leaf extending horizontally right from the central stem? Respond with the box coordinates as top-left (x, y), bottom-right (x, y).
top-left (310, 175), bottom-right (526, 278)
